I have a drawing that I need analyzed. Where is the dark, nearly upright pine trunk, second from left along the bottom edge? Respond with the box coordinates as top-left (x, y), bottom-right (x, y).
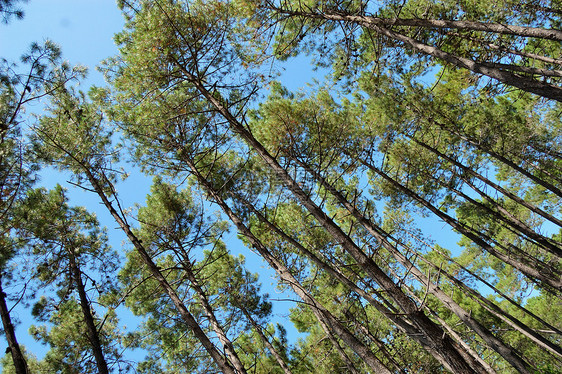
top-left (69, 253), bottom-right (109, 374)
